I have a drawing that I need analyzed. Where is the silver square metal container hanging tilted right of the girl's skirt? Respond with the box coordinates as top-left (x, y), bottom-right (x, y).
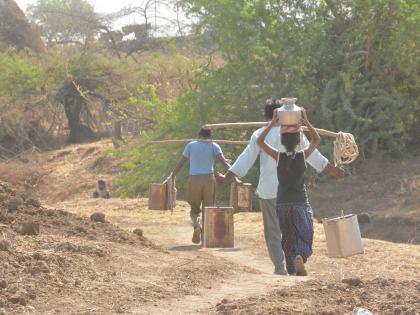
top-left (322, 214), bottom-right (364, 258)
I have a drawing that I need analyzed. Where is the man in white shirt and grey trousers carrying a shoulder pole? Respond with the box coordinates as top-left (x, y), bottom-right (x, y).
top-left (217, 99), bottom-right (344, 275)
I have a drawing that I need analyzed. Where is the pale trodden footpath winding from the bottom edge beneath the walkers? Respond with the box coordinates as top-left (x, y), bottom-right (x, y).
top-left (133, 218), bottom-right (305, 314)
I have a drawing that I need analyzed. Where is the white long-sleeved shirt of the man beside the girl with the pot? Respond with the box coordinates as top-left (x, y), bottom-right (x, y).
top-left (229, 127), bottom-right (328, 199)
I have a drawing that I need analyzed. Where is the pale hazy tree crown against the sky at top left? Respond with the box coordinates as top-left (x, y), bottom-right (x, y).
top-left (27, 0), bottom-right (99, 45)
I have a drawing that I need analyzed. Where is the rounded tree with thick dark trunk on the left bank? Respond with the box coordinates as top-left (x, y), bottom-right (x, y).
top-left (51, 51), bottom-right (133, 143)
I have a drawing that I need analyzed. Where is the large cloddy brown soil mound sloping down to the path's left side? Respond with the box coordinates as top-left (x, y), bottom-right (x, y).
top-left (0, 182), bottom-right (244, 314)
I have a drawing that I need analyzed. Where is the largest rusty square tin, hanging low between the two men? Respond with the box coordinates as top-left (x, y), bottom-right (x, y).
top-left (203, 207), bottom-right (234, 248)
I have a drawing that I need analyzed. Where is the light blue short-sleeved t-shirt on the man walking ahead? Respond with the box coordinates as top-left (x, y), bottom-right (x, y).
top-left (182, 141), bottom-right (222, 175)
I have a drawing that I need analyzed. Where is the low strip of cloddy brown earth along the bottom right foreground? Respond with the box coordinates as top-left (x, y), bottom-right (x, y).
top-left (212, 278), bottom-right (420, 315)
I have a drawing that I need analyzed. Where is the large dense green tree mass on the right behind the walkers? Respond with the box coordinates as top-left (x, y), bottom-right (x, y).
top-left (184, 0), bottom-right (420, 154)
